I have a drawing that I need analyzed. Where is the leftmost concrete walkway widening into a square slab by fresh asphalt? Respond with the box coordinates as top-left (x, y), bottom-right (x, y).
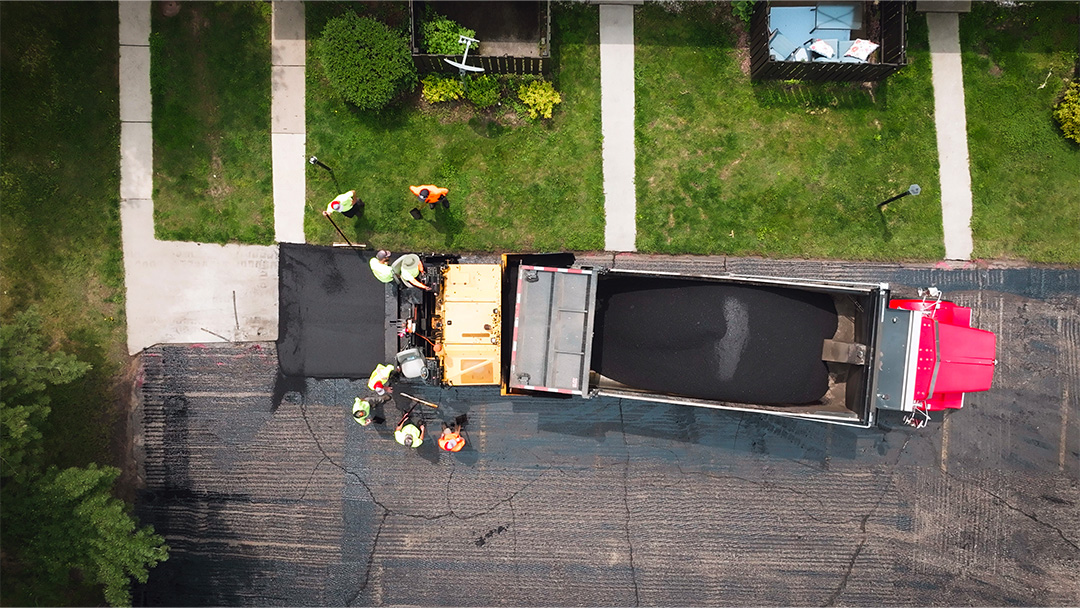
top-left (119, 1), bottom-right (278, 354)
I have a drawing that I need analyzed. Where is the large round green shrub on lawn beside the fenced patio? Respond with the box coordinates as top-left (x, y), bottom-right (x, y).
top-left (315, 13), bottom-right (416, 110)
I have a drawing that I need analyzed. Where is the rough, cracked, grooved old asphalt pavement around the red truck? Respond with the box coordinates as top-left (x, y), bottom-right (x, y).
top-left (136, 256), bottom-right (1080, 606)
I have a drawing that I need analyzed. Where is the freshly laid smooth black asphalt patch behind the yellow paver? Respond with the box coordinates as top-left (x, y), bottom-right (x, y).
top-left (278, 243), bottom-right (387, 378)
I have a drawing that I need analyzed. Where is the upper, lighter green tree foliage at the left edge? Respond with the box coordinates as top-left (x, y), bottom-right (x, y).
top-left (0, 309), bottom-right (90, 479)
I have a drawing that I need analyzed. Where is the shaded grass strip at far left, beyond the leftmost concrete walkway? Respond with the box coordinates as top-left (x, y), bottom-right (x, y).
top-left (0, 2), bottom-right (129, 606)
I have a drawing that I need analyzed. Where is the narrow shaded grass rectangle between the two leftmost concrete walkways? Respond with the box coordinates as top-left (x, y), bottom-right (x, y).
top-left (150, 2), bottom-right (274, 244)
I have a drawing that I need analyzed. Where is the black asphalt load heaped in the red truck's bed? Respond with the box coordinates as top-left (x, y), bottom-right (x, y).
top-left (592, 276), bottom-right (837, 405)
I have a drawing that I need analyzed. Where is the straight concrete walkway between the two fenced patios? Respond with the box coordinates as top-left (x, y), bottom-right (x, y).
top-left (599, 4), bottom-right (637, 252)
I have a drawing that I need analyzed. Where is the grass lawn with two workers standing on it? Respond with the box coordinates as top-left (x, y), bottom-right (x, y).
top-left (305, 3), bottom-right (604, 252)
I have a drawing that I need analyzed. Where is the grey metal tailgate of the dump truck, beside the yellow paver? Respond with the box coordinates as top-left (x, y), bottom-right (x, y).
top-left (508, 266), bottom-right (596, 396)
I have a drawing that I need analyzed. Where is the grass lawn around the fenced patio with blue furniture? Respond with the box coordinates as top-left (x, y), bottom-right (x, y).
top-left (634, 3), bottom-right (945, 259)
